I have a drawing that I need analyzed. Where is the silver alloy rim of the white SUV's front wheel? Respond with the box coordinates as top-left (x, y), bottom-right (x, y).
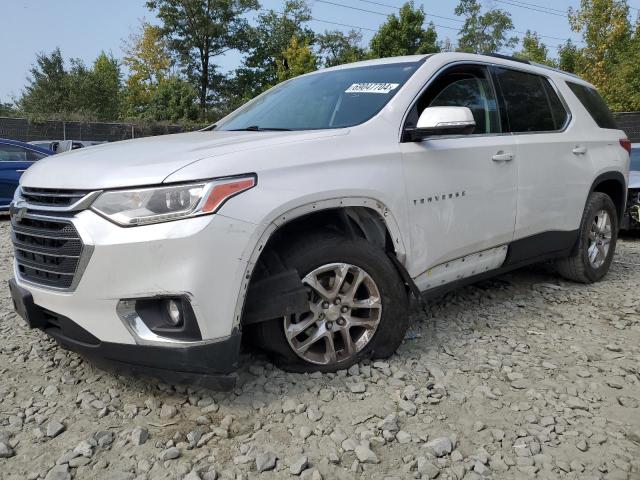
top-left (284, 263), bottom-right (382, 365)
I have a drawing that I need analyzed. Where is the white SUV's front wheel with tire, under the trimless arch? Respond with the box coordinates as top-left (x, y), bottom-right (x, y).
top-left (252, 232), bottom-right (408, 372)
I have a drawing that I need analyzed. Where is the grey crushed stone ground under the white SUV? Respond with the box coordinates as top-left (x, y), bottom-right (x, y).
top-left (0, 221), bottom-right (640, 480)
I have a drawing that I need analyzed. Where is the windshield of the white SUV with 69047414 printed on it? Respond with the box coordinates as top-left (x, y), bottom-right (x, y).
top-left (216, 62), bottom-right (421, 130)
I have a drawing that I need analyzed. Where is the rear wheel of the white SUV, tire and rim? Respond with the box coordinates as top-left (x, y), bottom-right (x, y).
top-left (556, 192), bottom-right (618, 283)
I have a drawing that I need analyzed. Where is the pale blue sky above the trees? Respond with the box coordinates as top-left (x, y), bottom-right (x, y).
top-left (0, 0), bottom-right (640, 102)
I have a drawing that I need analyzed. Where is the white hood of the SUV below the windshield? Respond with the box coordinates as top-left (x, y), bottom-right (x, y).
top-left (20, 130), bottom-right (344, 190)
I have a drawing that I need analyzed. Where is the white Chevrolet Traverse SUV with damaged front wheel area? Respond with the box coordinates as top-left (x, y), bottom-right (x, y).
top-left (11, 53), bottom-right (630, 388)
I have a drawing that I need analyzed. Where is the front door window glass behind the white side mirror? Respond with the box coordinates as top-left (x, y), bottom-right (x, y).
top-left (407, 65), bottom-right (501, 134)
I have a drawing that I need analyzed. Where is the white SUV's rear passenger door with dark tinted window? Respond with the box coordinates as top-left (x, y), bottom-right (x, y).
top-left (493, 67), bottom-right (590, 239)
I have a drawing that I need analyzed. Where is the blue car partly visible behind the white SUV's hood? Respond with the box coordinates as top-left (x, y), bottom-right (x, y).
top-left (0, 138), bottom-right (55, 212)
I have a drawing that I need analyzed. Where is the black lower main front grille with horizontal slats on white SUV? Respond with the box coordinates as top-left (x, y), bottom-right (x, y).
top-left (11, 214), bottom-right (84, 289)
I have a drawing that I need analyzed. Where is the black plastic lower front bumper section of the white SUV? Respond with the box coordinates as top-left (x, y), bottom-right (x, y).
top-left (9, 279), bottom-right (241, 390)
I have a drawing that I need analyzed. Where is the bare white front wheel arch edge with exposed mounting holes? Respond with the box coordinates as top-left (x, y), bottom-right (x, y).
top-left (233, 197), bottom-right (406, 328)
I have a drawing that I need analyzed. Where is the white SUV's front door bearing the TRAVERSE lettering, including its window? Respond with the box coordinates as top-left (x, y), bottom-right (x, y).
top-left (401, 64), bottom-right (517, 289)
